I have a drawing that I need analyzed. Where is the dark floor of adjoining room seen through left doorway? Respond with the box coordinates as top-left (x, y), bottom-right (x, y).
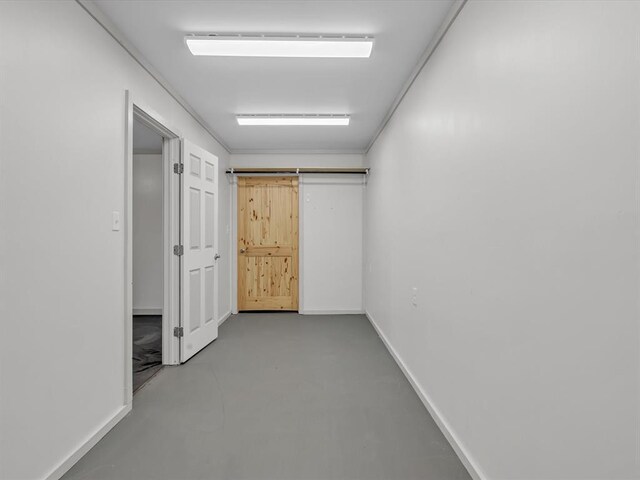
top-left (133, 315), bottom-right (162, 392)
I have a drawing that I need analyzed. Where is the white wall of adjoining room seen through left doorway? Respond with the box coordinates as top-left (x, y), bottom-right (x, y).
top-left (133, 154), bottom-right (164, 315)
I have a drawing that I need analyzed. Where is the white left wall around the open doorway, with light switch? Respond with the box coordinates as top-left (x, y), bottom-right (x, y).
top-left (0, 1), bottom-right (230, 479)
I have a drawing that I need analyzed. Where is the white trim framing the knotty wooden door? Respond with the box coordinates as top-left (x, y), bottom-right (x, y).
top-left (228, 173), bottom-right (304, 315)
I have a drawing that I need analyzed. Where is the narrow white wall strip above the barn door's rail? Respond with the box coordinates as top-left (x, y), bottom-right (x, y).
top-left (229, 153), bottom-right (365, 168)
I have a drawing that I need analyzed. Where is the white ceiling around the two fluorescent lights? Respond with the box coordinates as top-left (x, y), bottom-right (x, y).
top-left (95, 0), bottom-right (453, 152)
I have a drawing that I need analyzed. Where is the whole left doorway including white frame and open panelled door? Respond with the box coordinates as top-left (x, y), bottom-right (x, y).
top-left (124, 91), bottom-right (220, 406)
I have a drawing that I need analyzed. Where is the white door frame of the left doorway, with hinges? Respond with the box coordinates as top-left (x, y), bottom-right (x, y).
top-left (123, 90), bottom-right (182, 405)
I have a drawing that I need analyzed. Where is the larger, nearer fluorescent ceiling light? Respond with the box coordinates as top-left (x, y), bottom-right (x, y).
top-left (185, 34), bottom-right (373, 58)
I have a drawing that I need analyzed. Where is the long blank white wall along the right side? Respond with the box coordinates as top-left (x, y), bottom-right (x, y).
top-left (365, 1), bottom-right (640, 480)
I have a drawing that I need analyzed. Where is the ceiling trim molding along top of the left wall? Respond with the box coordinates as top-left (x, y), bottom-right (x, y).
top-left (76, 0), bottom-right (231, 154)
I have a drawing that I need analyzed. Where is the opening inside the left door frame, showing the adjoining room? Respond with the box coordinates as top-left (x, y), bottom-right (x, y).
top-left (131, 118), bottom-right (165, 394)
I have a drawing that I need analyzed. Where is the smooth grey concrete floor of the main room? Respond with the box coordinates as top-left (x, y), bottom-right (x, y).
top-left (63, 313), bottom-right (470, 480)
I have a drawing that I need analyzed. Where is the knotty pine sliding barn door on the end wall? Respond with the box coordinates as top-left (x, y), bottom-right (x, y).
top-left (238, 177), bottom-right (298, 311)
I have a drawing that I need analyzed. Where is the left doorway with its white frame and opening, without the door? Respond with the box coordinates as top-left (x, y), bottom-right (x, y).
top-left (124, 96), bottom-right (181, 406)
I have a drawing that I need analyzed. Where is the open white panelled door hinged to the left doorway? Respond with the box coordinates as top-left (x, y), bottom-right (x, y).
top-left (180, 140), bottom-right (218, 362)
